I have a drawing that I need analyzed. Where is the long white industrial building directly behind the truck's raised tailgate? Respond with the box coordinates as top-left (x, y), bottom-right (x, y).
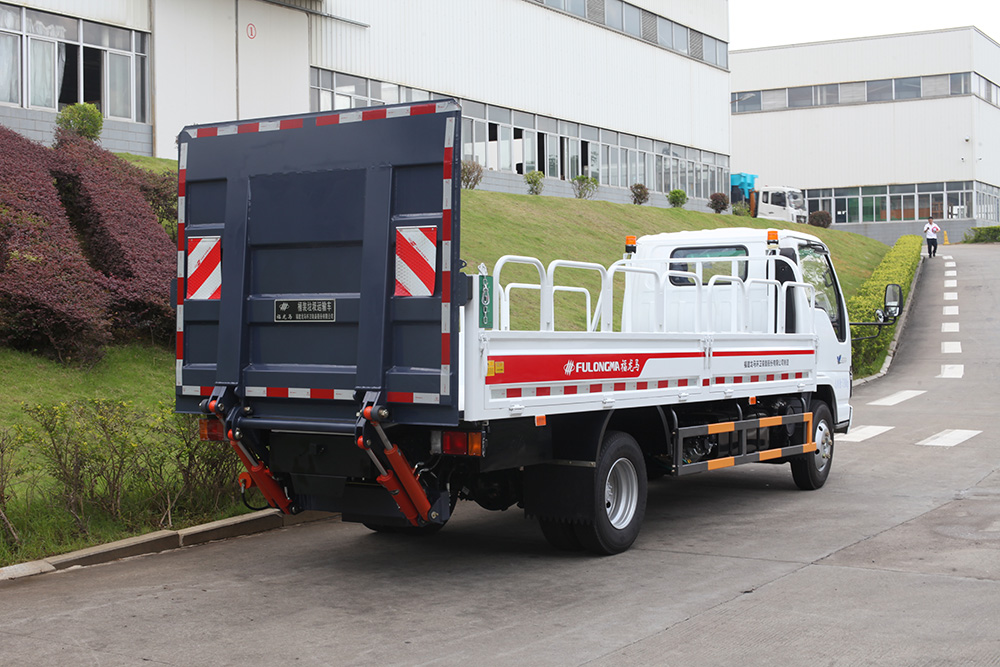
top-left (0, 0), bottom-right (730, 205)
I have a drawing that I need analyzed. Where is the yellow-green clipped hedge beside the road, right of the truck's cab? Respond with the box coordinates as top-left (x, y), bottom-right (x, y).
top-left (847, 236), bottom-right (923, 377)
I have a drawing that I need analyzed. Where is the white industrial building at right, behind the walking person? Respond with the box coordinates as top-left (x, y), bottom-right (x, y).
top-left (730, 27), bottom-right (1000, 243)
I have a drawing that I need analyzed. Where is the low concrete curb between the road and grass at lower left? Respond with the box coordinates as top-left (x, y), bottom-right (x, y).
top-left (0, 509), bottom-right (340, 581)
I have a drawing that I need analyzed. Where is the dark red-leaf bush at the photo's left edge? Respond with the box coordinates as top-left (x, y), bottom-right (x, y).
top-left (0, 126), bottom-right (110, 362)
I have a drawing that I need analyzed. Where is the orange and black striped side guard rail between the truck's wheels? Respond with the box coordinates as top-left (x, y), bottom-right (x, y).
top-left (674, 412), bottom-right (816, 475)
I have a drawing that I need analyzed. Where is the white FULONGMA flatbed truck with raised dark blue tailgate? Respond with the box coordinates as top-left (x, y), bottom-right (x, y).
top-left (177, 100), bottom-right (898, 554)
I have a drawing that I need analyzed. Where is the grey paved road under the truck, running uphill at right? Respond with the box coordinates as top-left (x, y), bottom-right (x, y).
top-left (0, 246), bottom-right (1000, 667)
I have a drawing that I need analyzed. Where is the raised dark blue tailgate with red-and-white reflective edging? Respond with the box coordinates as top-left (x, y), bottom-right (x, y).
top-left (177, 100), bottom-right (464, 432)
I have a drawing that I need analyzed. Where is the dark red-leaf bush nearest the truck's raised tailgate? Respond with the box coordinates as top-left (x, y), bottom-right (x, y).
top-left (53, 131), bottom-right (177, 342)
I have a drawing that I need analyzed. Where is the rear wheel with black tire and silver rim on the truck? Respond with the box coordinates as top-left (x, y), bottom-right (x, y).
top-left (574, 431), bottom-right (647, 556)
